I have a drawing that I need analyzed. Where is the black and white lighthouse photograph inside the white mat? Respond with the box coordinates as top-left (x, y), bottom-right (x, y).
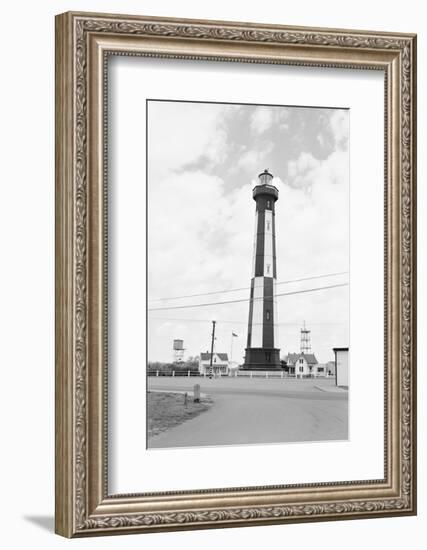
top-left (144, 99), bottom-right (353, 449)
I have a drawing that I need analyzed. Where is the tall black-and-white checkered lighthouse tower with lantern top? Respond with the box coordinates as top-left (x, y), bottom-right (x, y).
top-left (243, 169), bottom-right (280, 370)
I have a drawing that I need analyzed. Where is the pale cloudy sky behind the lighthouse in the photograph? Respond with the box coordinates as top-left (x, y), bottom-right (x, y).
top-left (147, 100), bottom-right (350, 363)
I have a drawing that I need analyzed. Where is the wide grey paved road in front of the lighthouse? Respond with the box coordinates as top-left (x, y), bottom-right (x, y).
top-left (148, 377), bottom-right (348, 448)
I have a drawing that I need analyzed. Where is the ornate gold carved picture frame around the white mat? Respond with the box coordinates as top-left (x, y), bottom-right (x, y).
top-left (55, 13), bottom-right (416, 537)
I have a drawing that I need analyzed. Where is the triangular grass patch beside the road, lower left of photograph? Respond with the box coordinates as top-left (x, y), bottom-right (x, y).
top-left (147, 391), bottom-right (213, 439)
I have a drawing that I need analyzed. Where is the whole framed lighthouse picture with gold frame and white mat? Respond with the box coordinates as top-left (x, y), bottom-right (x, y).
top-left (56, 12), bottom-right (416, 537)
